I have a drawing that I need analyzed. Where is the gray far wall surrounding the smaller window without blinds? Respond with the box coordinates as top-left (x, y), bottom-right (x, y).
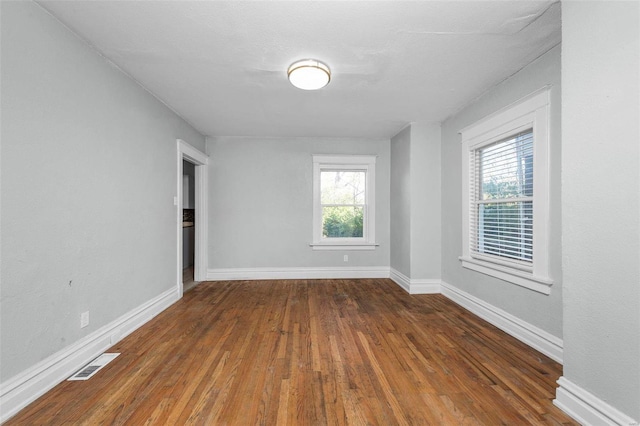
top-left (207, 137), bottom-right (389, 268)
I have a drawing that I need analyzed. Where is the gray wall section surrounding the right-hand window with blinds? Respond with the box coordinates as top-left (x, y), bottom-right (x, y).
top-left (442, 46), bottom-right (562, 338)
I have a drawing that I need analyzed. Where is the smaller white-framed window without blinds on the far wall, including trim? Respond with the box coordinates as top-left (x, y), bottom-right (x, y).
top-left (311, 155), bottom-right (376, 250)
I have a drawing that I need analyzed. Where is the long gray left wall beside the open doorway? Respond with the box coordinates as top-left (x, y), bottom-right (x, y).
top-left (0, 2), bottom-right (204, 381)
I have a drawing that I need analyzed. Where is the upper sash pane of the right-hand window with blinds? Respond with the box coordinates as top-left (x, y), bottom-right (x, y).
top-left (479, 130), bottom-right (533, 200)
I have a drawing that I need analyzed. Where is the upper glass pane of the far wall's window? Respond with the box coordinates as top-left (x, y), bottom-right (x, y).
top-left (320, 170), bottom-right (366, 204)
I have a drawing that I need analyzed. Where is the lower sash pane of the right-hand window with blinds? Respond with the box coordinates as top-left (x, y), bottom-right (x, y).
top-left (476, 201), bottom-right (533, 262)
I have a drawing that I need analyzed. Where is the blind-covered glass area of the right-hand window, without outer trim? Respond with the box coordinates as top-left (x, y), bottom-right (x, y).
top-left (469, 129), bottom-right (533, 266)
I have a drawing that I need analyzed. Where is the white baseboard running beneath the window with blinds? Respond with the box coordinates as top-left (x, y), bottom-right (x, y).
top-left (441, 282), bottom-right (563, 364)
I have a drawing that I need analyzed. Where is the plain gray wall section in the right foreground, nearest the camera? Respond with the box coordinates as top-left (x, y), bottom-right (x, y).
top-left (562, 2), bottom-right (640, 421)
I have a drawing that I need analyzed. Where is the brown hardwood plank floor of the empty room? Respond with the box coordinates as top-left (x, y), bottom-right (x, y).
top-left (6, 279), bottom-right (577, 425)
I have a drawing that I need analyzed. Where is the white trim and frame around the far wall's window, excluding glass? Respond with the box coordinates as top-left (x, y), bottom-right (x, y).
top-left (310, 155), bottom-right (378, 250)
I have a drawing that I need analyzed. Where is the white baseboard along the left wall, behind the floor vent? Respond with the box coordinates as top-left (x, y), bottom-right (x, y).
top-left (0, 288), bottom-right (180, 423)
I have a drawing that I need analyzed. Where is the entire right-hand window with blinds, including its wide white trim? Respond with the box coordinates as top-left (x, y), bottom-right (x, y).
top-left (460, 89), bottom-right (552, 294)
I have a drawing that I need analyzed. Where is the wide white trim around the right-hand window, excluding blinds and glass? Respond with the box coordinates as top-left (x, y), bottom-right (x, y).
top-left (459, 87), bottom-right (553, 294)
